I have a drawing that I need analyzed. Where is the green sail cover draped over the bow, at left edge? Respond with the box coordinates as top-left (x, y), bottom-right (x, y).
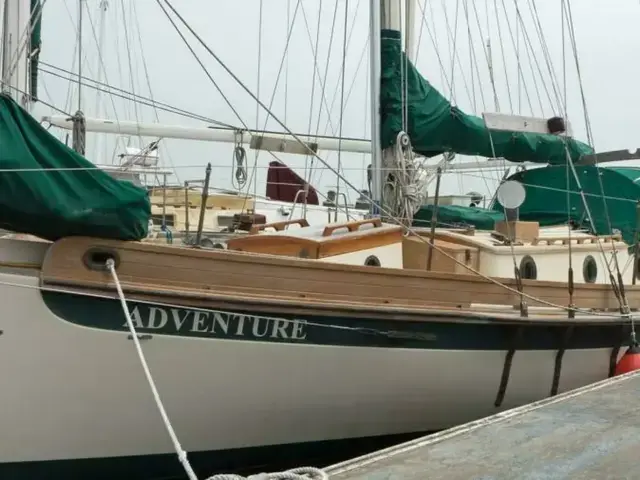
top-left (0, 95), bottom-right (151, 240)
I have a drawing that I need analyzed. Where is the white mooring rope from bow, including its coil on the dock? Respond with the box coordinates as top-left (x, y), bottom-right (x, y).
top-left (105, 258), bottom-right (329, 480)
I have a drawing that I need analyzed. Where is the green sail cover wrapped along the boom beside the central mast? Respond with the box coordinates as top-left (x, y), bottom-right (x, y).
top-left (380, 30), bottom-right (593, 164)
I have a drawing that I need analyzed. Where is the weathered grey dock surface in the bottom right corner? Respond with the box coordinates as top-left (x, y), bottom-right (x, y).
top-left (326, 372), bottom-right (640, 480)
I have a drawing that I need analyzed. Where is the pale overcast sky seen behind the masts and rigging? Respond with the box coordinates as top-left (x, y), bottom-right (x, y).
top-left (35, 0), bottom-right (640, 203)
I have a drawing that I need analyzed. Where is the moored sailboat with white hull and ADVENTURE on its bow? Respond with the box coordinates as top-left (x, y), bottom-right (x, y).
top-left (0, 0), bottom-right (640, 478)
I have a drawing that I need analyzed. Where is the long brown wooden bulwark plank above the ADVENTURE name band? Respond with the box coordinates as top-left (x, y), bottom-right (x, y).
top-left (41, 237), bottom-right (640, 316)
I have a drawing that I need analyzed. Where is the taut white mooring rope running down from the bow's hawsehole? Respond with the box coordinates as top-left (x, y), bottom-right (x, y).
top-left (106, 258), bottom-right (198, 480)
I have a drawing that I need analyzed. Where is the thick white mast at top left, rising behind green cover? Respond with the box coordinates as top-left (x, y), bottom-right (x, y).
top-left (0, 0), bottom-right (32, 110)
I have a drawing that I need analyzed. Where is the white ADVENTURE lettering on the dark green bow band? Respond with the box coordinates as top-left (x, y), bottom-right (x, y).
top-left (123, 305), bottom-right (307, 341)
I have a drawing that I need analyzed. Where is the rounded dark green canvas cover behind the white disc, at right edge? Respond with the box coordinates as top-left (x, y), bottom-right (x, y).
top-left (500, 165), bottom-right (640, 245)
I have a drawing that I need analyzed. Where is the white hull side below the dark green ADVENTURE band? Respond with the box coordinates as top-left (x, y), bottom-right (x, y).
top-left (0, 274), bottom-right (611, 466)
